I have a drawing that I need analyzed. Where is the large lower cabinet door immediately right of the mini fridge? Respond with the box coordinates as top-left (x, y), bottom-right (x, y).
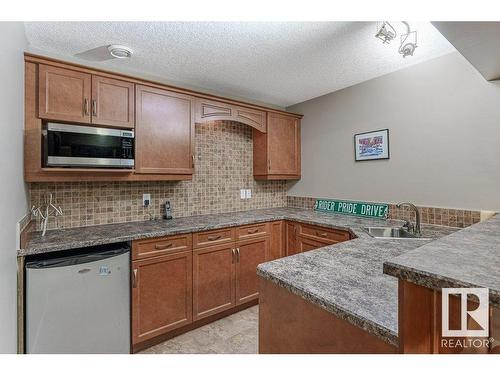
top-left (132, 251), bottom-right (193, 344)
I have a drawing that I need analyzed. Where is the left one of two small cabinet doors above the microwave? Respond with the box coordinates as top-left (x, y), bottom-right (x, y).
top-left (38, 64), bottom-right (91, 123)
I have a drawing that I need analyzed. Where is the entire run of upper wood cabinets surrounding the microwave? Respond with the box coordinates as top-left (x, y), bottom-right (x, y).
top-left (24, 53), bottom-right (302, 182)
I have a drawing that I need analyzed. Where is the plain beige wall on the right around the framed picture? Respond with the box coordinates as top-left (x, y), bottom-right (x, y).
top-left (288, 51), bottom-right (500, 211)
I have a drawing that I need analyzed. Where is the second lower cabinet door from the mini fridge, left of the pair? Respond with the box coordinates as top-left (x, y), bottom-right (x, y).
top-left (193, 242), bottom-right (235, 320)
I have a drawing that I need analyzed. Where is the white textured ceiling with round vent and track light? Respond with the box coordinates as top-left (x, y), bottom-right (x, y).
top-left (26, 22), bottom-right (454, 107)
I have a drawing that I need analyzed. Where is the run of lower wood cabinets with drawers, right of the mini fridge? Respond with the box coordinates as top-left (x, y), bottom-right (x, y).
top-left (132, 221), bottom-right (350, 348)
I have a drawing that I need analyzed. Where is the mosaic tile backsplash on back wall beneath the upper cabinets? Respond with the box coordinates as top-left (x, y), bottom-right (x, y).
top-left (29, 121), bottom-right (287, 229)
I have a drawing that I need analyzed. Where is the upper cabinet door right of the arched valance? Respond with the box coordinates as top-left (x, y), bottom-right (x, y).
top-left (267, 112), bottom-right (300, 175)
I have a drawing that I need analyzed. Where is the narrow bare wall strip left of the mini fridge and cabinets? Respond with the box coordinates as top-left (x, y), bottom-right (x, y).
top-left (0, 22), bottom-right (27, 353)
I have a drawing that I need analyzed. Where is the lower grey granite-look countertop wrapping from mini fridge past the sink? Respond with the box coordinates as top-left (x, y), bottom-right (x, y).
top-left (23, 208), bottom-right (458, 345)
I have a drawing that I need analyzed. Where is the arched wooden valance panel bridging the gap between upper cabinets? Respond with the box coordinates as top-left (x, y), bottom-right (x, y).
top-left (195, 99), bottom-right (267, 133)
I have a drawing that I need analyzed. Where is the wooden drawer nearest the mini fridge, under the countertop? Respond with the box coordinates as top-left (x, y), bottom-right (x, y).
top-left (132, 234), bottom-right (192, 260)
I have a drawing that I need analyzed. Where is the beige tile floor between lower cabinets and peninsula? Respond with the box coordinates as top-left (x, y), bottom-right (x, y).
top-left (141, 306), bottom-right (259, 354)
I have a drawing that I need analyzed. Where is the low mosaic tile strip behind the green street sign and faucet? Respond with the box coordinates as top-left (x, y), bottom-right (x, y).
top-left (287, 196), bottom-right (481, 228)
